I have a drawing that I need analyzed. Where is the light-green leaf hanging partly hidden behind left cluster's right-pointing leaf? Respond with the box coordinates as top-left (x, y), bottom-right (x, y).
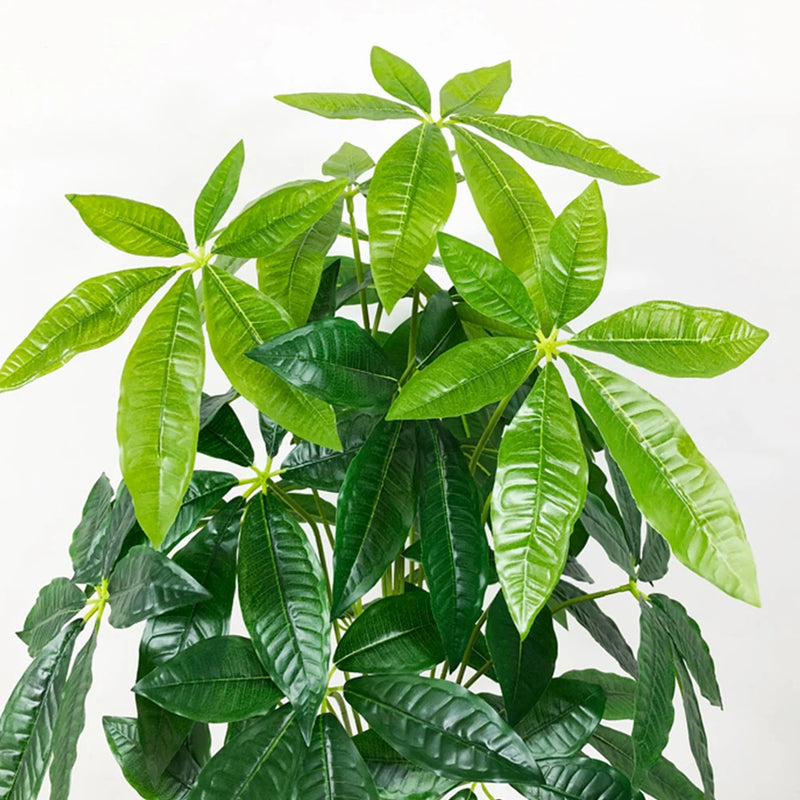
top-left (256, 197), bottom-right (344, 325)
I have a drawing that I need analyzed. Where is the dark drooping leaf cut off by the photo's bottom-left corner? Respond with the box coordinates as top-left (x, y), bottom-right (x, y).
top-left (0, 620), bottom-right (83, 800)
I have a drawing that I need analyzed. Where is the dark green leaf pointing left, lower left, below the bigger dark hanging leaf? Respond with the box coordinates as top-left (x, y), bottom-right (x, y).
top-left (133, 636), bottom-right (283, 722)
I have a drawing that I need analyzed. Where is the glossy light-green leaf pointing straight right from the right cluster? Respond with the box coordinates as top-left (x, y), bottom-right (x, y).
top-left (570, 300), bottom-right (768, 378)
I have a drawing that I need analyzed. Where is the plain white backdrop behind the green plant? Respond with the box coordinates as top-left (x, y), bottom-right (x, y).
top-left (0, 0), bottom-right (800, 800)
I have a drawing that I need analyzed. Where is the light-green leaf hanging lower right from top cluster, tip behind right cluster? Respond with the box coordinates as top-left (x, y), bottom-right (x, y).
top-left (451, 128), bottom-right (553, 310)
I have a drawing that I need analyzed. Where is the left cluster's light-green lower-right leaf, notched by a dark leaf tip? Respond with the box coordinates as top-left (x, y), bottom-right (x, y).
top-left (203, 266), bottom-right (340, 449)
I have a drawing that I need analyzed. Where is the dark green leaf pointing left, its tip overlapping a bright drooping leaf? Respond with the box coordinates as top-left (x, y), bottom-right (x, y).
top-left (247, 317), bottom-right (397, 408)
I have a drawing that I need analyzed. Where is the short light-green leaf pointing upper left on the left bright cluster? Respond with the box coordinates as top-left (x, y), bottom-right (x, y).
top-left (67, 194), bottom-right (189, 253)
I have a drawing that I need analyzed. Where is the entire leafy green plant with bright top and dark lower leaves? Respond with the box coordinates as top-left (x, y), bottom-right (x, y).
top-left (0, 47), bottom-right (766, 800)
